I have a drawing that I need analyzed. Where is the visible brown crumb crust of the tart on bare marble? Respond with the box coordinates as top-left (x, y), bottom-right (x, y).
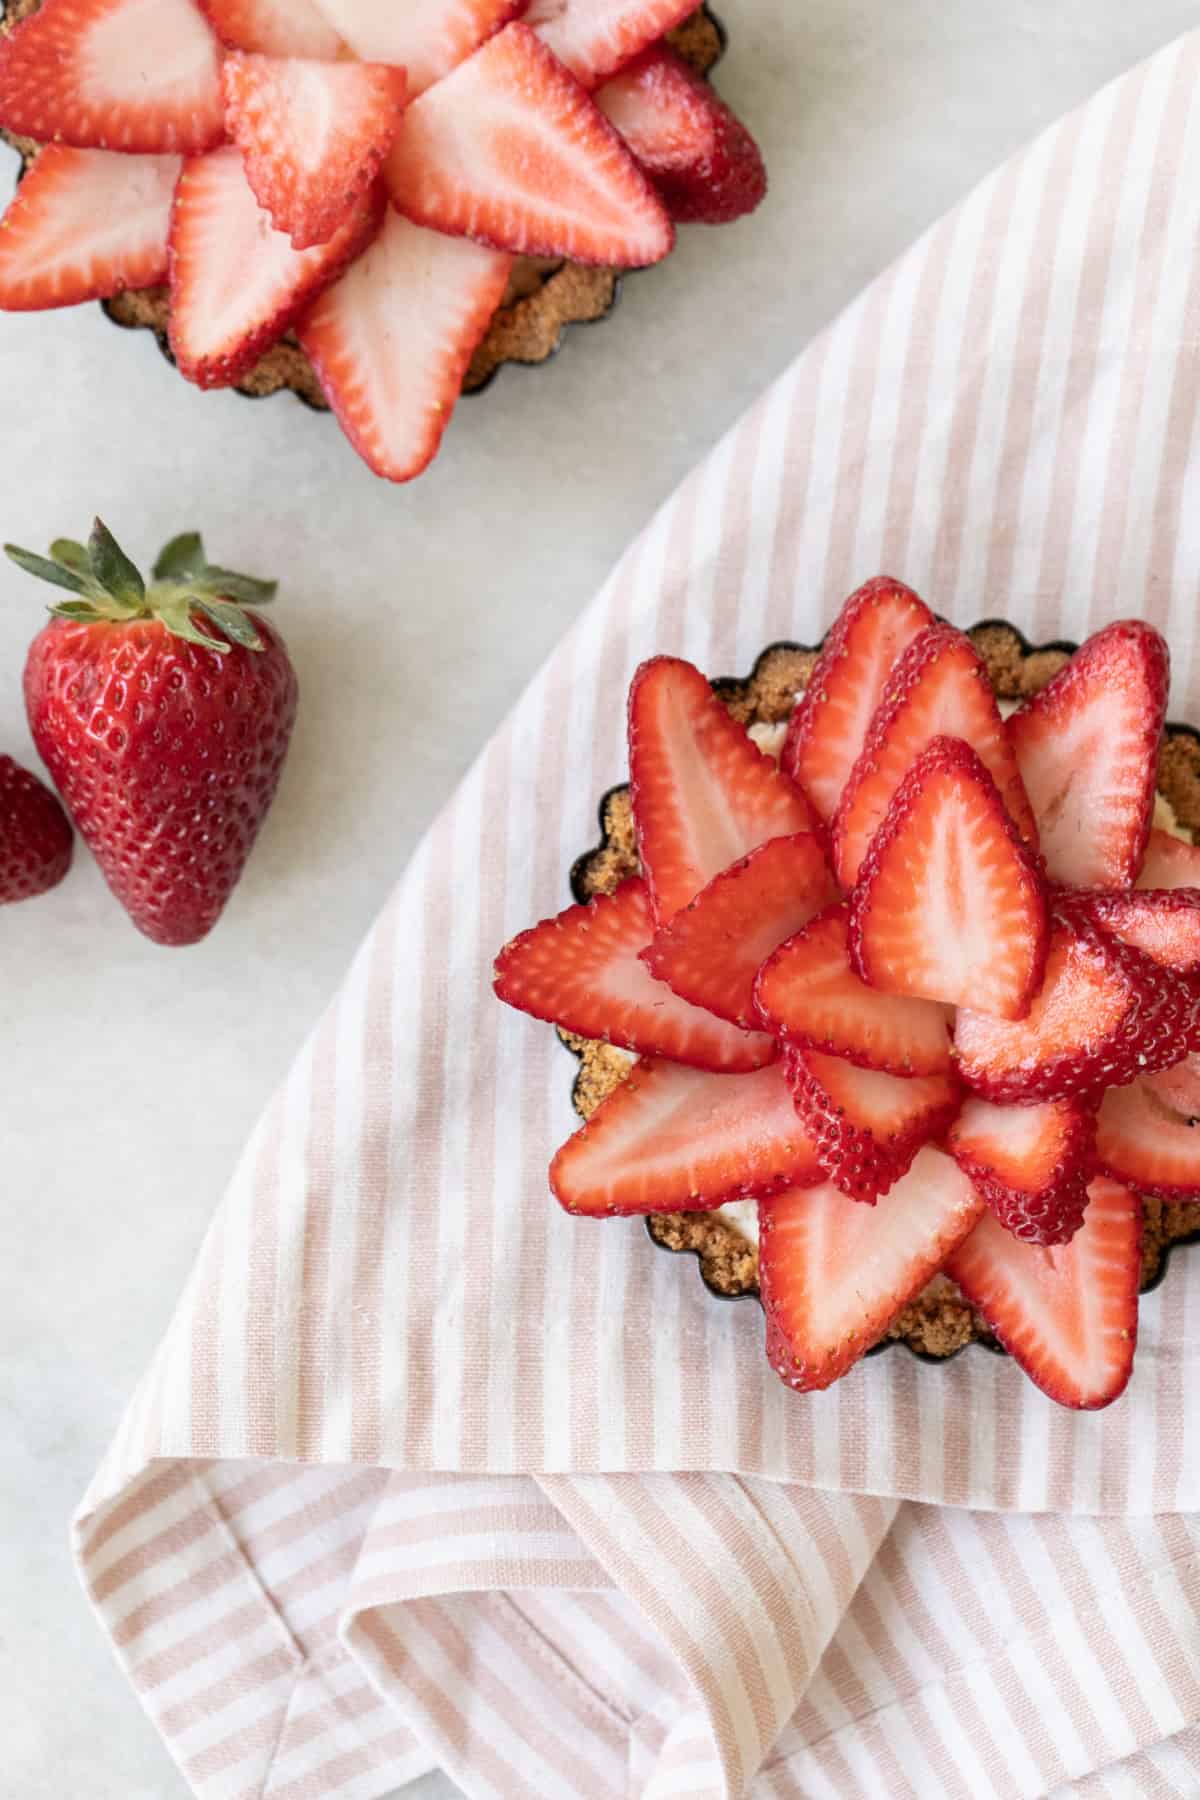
top-left (0, 0), bottom-right (725, 412)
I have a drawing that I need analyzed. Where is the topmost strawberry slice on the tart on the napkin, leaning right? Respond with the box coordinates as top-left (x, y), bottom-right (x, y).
top-left (783, 574), bottom-right (934, 821)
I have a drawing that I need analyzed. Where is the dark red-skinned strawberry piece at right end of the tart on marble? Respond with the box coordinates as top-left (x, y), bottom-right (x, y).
top-left (596, 43), bottom-right (766, 225)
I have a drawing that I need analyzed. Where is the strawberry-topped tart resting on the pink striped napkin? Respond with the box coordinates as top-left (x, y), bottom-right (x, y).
top-left (495, 578), bottom-right (1200, 1408)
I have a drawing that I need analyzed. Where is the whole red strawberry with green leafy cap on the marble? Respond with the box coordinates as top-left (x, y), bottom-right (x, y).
top-left (5, 518), bottom-right (297, 943)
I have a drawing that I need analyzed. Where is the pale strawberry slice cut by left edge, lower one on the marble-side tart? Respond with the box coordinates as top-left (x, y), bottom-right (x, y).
top-left (0, 144), bottom-right (182, 313)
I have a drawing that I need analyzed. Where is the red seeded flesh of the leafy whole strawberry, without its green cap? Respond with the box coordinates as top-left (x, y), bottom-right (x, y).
top-left (25, 617), bottom-right (297, 945)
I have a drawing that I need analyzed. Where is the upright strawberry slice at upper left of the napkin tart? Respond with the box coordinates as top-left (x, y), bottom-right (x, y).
top-left (630, 657), bottom-right (817, 925)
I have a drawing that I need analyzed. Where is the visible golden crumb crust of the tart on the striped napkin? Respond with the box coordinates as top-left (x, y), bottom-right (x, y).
top-left (560, 621), bottom-right (1200, 1361)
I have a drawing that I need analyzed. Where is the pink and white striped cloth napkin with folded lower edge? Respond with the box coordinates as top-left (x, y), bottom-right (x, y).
top-left (76, 32), bottom-right (1200, 1800)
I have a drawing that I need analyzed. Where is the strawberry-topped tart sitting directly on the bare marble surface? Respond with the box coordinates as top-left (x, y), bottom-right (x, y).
top-left (0, 0), bottom-right (766, 481)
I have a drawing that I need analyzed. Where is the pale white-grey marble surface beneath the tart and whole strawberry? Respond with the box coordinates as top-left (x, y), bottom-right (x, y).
top-left (0, 0), bottom-right (1196, 1800)
